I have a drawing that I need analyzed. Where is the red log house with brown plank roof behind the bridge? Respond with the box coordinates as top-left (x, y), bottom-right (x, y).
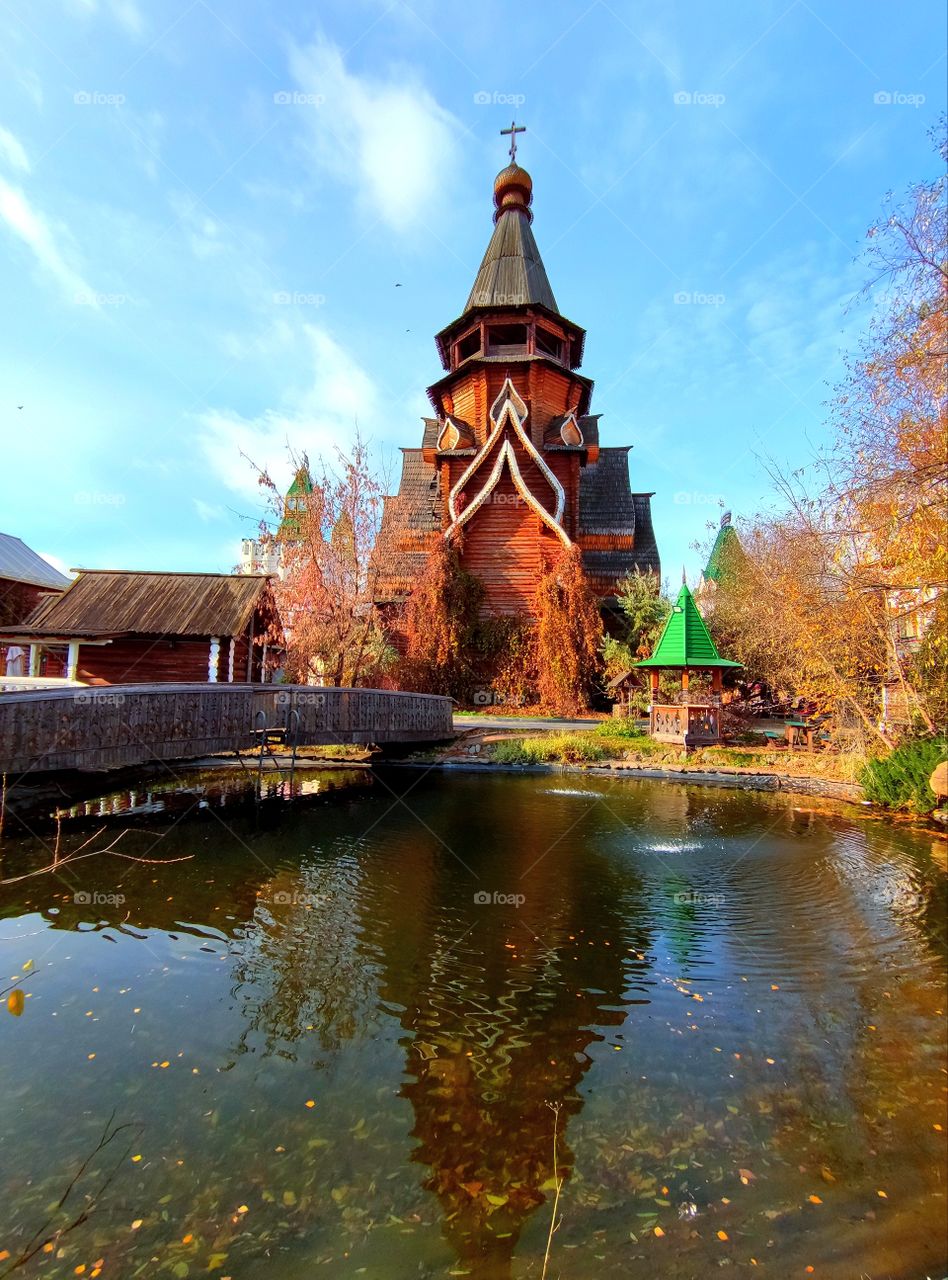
top-left (0, 570), bottom-right (283, 685)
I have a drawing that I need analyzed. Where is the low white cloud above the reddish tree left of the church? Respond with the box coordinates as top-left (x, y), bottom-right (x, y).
top-left (198, 324), bottom-right (379, 502)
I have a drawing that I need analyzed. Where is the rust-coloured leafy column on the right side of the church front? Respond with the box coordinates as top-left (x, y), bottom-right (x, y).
top-left (533, 545), bottom-right (603, 716)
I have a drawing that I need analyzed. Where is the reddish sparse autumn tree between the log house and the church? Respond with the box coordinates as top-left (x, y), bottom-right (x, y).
top-left (248, 435), bottom-right (393, 685)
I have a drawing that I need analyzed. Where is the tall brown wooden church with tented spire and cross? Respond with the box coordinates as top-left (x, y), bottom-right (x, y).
top-left (383, 125), bottom-right (660, 614)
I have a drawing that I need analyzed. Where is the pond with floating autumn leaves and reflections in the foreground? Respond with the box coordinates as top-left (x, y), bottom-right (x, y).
top-left (0, 769), bottom-right (948, 1280)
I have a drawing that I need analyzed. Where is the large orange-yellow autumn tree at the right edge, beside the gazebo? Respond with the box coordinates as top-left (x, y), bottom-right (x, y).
top-left (713, 124), bottom-right (948, 745)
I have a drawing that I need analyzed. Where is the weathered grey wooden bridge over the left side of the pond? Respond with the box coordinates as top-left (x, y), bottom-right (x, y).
top-left (0, 684), bottom-right (452, 782)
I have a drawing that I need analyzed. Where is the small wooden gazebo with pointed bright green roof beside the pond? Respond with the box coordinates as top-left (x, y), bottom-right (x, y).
top-left (635, 584), bottom-right (741, 746)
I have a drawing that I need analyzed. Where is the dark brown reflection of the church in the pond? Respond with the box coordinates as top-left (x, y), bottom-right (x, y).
top-left (355, 778), bottom-right (650, 1276)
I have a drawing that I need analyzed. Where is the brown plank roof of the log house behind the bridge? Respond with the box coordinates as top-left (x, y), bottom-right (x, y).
top-left (9, 570), bottom-right (269, 637)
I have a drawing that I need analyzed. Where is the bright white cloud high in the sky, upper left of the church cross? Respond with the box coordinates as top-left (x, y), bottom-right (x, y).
top-left (280, 36), bottom-right (461, 232)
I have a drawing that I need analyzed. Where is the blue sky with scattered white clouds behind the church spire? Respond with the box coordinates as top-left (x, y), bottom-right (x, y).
top-left (0, 0), bottom-right (945, 581)
